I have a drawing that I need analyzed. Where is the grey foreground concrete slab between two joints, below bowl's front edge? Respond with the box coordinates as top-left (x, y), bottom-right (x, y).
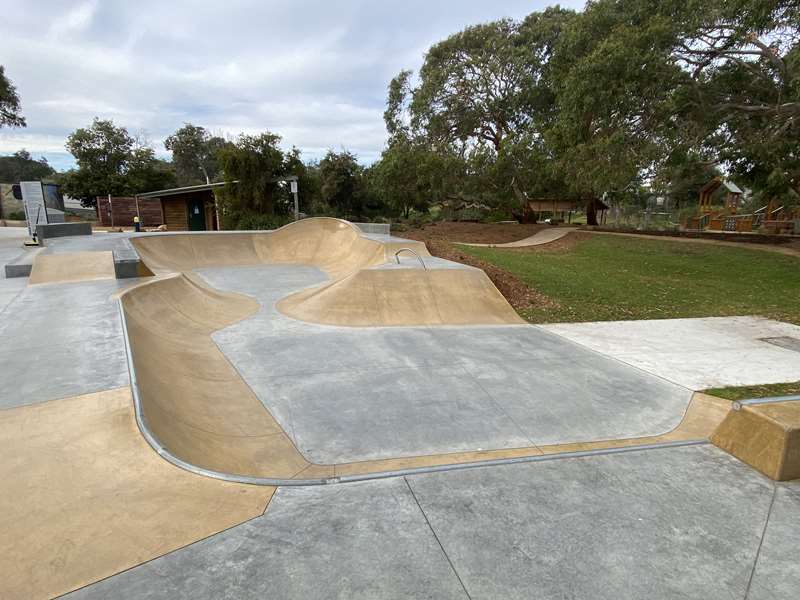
top-left (408, 446), bottom-right (776, 600)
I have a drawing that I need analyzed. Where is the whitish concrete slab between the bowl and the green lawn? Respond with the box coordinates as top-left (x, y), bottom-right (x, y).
top-left (541, 317), bottom-right (800, 390)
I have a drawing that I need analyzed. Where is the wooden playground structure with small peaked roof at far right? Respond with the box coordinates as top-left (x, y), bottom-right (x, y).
top-left (685, 177), bottom-right (800, 234)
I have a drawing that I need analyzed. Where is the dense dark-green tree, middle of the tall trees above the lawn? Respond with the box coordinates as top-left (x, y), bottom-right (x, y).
top-left (545, 0), bottom-right (683, 225)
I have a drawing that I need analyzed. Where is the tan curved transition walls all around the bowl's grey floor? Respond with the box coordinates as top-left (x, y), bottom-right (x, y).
top-left (120, 218), bottom-right (727, 485)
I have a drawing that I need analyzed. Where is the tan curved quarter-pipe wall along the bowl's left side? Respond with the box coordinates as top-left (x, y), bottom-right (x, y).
top-left (121, 275), bottom-right (308, 478)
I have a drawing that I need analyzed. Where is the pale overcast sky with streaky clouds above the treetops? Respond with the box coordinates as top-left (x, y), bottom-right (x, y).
top-left (0, 0), bottom-right (584, 169)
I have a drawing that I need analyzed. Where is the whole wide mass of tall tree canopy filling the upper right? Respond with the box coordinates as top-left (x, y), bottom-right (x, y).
top-left (374, 0), bottom-right (800, 223)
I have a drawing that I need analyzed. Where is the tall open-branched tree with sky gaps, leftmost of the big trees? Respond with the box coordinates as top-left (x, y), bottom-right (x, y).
top-left (384, 7), bottom-right (575, 213)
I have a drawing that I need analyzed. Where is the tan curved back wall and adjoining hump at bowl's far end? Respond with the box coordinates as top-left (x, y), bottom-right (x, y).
top-left (132, 218), bottom-right (524, 326)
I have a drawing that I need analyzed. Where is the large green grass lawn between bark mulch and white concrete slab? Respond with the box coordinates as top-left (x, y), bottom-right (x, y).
top-left (460, 235), bottom-right (800, 324)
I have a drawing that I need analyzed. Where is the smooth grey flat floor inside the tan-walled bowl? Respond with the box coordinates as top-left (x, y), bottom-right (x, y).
top-left (199, 265), bottom-right (691, 464)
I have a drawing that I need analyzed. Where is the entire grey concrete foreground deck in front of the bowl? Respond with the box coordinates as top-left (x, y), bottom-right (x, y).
top-left (69, 446), bottom-right (800, 600)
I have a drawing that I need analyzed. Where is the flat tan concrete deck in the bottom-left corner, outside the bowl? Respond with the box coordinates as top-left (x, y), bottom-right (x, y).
top-left (0, 388), bottom-right (274, 599)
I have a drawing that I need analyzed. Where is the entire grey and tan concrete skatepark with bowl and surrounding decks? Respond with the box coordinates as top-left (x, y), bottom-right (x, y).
top-left (0, 218), bottom-right (800, 598)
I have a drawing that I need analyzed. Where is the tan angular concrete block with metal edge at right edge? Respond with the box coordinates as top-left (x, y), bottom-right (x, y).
top-left (711, 402), bottom-right (800, 481)
